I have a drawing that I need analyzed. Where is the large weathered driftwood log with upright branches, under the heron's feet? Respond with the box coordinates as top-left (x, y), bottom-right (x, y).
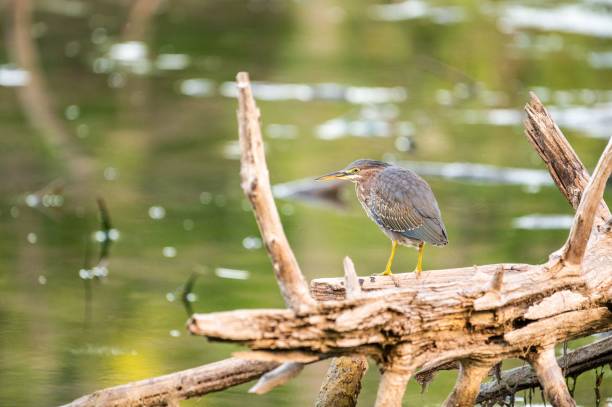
top-left (64, 78), bottom-right (612, 406)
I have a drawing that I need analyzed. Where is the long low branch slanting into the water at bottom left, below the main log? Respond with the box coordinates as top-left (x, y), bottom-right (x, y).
top-left (65, 358), bottom-right (278, 407)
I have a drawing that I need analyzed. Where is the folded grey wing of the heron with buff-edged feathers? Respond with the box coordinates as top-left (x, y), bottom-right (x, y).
top-left (370, 167), bottom-right (447, 244)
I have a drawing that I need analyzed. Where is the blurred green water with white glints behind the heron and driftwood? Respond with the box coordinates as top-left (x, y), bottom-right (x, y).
top-left (0, 0), bottom-right (612, 406)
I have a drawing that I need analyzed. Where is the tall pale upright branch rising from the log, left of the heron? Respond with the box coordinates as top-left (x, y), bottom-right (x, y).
top-left (236, 72), bottom-right (316, 313)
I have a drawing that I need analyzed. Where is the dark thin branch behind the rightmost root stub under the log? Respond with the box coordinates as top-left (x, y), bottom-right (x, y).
top-left (476, 336), bottom-right (612, 403)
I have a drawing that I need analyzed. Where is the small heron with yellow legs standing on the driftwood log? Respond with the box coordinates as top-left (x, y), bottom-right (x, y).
top-left (317, 160), bottom-right (448, 277)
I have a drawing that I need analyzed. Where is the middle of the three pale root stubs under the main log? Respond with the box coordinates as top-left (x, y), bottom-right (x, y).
top-left (443, 359), bottom-right (495, 407)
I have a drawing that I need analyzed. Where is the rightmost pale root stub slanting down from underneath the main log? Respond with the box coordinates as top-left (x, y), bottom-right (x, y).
top-left (526, 345), bottom-right (576, 407)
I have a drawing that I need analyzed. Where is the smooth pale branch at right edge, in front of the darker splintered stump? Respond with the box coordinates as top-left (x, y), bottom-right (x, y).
top-left (563, 139), bottom-right (612, 265)
